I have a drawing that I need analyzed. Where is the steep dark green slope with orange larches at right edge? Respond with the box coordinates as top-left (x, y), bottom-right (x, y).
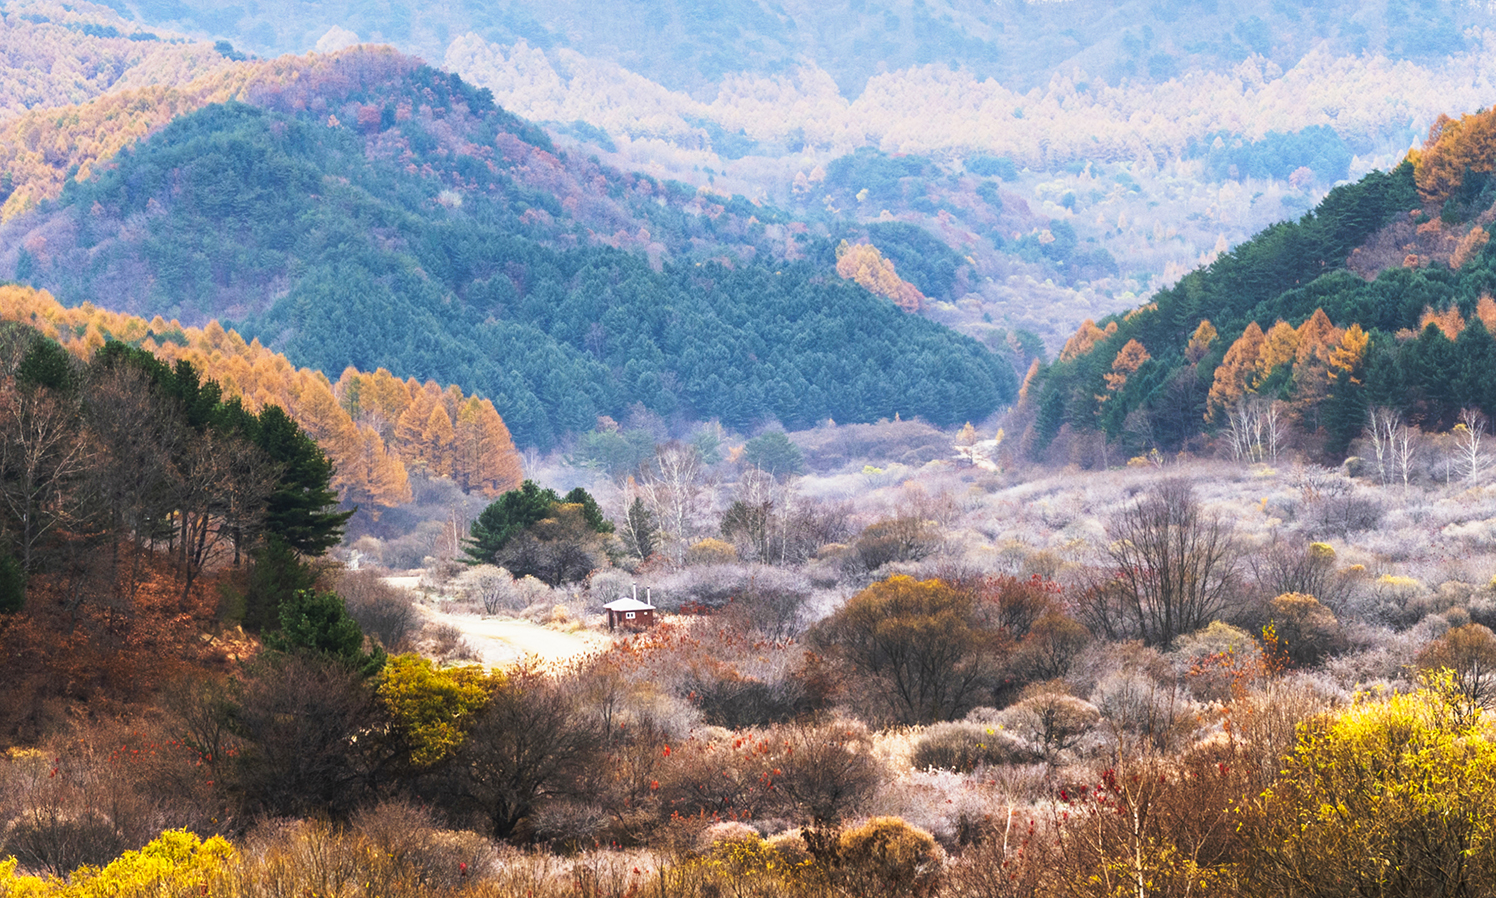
top-left (1020, 112), bottom-right (1496, 464)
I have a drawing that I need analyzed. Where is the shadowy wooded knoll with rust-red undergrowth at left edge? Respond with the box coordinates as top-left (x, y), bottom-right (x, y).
top-left (0, 315), bottom-right (353, 738)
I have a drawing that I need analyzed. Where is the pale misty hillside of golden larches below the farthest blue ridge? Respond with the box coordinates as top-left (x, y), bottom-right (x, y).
top-left (444, 19), bottom-right (1496, 353)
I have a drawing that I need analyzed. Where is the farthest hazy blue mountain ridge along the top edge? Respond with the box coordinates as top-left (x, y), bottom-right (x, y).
top-left (99, 0), bottom-right (1492, 97)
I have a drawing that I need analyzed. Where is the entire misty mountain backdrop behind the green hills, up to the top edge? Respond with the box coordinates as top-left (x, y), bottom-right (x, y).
top-left (20, 0), bottom-right (1496, 360)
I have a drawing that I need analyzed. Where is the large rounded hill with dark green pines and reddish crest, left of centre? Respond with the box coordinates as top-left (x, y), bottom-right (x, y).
top-left (3, 51), bottom-right (1016, 446)
